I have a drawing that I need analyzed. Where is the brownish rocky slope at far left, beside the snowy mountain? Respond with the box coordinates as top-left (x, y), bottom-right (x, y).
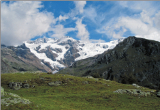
top-left (1, 44), bottom-right (51, 73)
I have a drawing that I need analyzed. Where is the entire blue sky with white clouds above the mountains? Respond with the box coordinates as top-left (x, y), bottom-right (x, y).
top-left (1, 1), bottom-right (160, 45)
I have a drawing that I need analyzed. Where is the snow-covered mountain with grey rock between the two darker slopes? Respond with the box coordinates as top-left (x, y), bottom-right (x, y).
top-left (24, 37), bottom-right (124, 71)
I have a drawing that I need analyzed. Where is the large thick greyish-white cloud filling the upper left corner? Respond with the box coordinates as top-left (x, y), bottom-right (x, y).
top-left (1, 1), bottom-right (56, 45)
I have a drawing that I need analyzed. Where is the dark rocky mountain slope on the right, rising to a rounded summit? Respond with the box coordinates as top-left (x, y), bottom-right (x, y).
top-left (60, 36), bottom-right (160, 89)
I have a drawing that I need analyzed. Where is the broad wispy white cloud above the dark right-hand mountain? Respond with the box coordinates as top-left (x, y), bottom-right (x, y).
top-left (96, 1), bottom-right (160, 41)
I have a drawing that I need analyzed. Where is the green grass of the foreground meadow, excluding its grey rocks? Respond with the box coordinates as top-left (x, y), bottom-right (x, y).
top-left (1, 73), bottom-right (160, 110)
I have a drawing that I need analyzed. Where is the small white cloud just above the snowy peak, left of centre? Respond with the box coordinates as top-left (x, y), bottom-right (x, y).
top-left (50, 24), bottom-right (76, 38)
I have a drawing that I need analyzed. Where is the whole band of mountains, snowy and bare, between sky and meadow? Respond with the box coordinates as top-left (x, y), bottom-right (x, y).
top-left (1, 36), bottom-right (160, 89)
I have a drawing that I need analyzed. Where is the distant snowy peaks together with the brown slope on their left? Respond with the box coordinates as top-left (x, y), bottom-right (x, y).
top-left (1, 37), bottom-right (124, 73)
